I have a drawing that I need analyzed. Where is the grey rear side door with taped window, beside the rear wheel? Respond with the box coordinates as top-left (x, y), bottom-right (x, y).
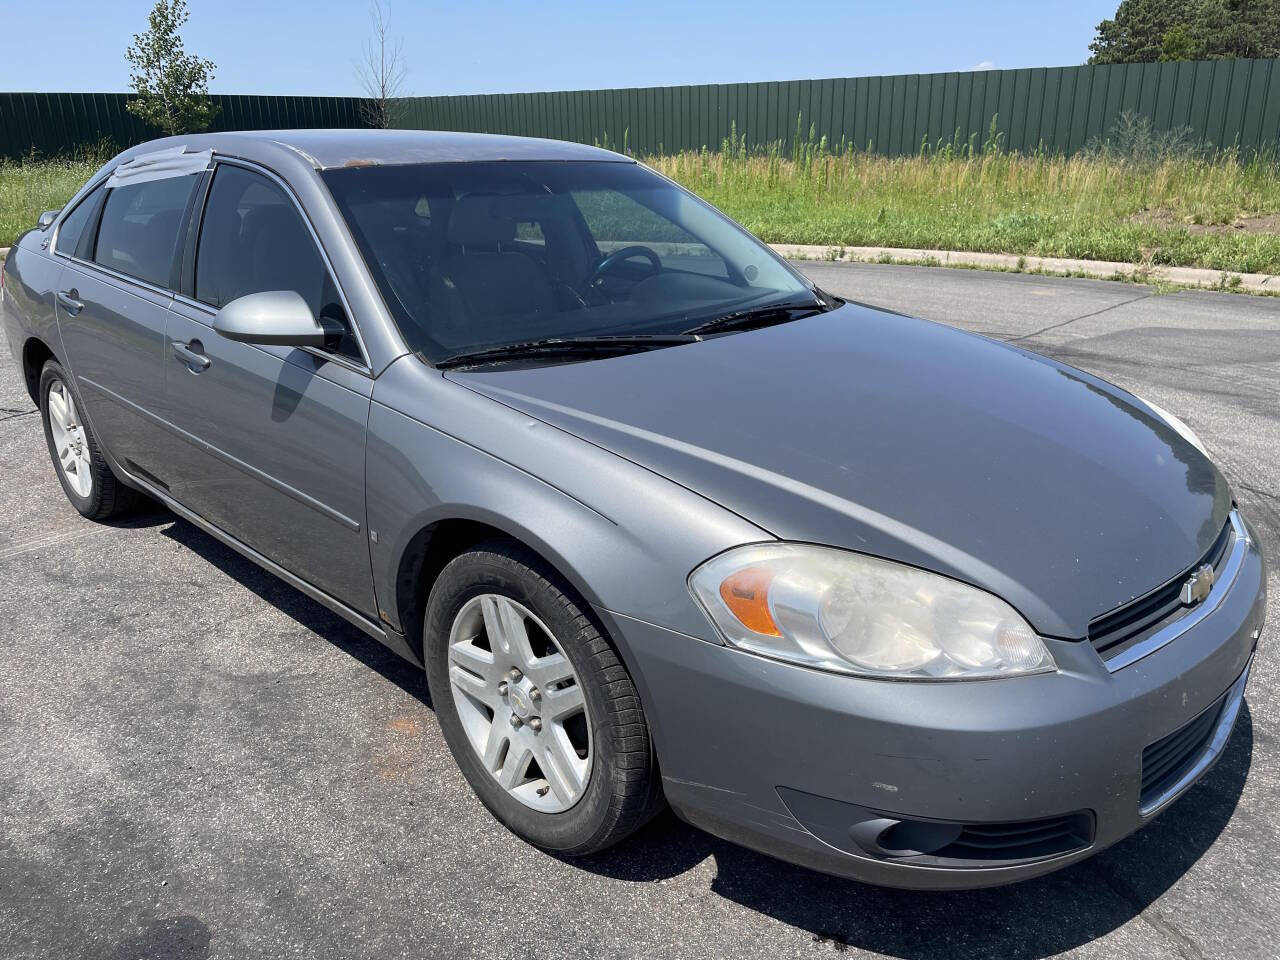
top-left (55, 174), bottom-right (201, 479)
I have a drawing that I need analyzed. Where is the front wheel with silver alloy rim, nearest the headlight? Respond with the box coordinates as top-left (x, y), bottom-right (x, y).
top-left (422, 540), bottom-right (662, 856)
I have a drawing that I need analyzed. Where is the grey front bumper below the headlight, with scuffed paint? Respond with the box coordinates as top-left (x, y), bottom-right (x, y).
top-left (602, 522), bottom-right (1266, 890)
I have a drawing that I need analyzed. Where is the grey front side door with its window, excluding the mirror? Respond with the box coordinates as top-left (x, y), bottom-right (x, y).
top-left (165, 161), bottom-right (375, 614)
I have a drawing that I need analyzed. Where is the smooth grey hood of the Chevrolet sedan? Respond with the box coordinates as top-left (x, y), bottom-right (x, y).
top-left (447, 305), bottom-right (1230, 637)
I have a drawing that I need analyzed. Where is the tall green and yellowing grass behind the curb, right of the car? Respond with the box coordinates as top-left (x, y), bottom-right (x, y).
top-left (646, 122), bottom-right (1280, 273)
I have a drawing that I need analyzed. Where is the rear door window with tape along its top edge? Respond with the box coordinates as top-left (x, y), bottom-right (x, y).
top-left (93, 175), bottom-right (200, 287)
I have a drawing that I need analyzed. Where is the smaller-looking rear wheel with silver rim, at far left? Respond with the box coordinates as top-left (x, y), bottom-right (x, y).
top-left (38, 360), bottom-right (140, 520)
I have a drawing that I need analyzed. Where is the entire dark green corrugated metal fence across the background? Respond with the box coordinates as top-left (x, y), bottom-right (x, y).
top-left (0, 60), bottom-right (1280, 156)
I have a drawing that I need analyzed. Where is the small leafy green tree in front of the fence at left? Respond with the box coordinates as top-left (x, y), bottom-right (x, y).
top-left (124, 0), bottom-right (218, 137)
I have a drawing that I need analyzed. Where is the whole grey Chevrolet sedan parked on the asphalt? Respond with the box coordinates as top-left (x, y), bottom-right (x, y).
top-left (0, 131), bottom-right (1265, 888)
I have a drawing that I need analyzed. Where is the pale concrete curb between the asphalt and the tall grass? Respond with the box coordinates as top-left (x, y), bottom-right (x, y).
top-left (769, 243), bottom-right (1280, 293)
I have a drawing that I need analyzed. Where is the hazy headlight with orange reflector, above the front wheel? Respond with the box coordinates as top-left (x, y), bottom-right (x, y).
top-left (689, 544), bottom-right (1056, 680)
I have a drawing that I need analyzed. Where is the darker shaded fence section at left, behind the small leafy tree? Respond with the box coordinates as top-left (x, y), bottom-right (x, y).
top-left (0, 93), bottom-right (364, 159)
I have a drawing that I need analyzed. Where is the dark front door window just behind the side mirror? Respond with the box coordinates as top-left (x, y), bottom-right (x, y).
top-left (196, 164), bottom-right (360, 360)
